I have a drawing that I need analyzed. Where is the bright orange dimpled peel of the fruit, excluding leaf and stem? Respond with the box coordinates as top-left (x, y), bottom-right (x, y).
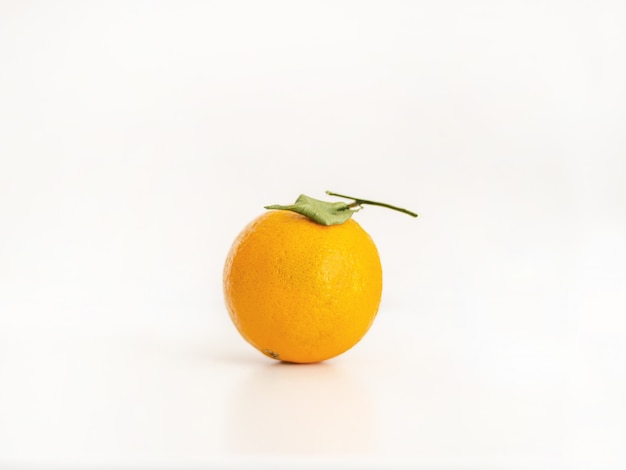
top-left (224, 210), bottom-right (382, 363)
